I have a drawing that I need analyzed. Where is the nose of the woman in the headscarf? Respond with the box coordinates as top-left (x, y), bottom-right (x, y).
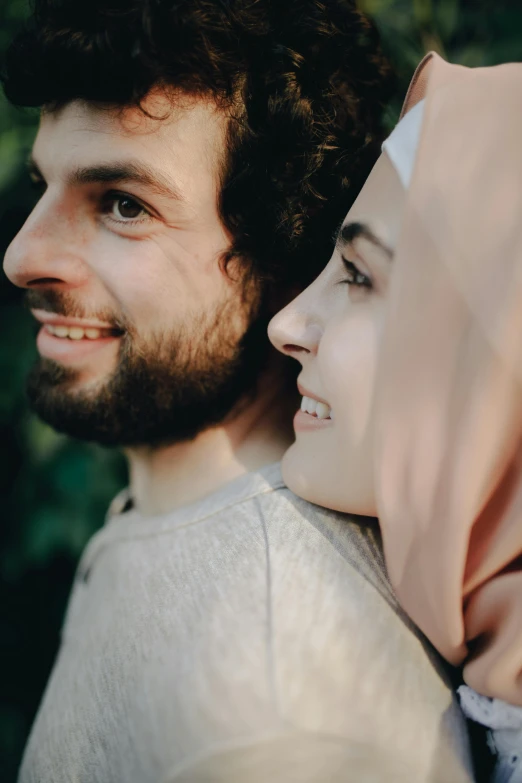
top-left (268, 292), bottom-right (321, 361)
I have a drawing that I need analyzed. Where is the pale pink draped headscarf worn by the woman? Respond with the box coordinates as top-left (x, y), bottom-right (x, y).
top-left (376, 54), bottom-right (522, 705)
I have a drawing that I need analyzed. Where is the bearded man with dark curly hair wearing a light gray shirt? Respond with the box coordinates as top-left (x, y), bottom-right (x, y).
top-left (5, 0), bottom-right (469, 783)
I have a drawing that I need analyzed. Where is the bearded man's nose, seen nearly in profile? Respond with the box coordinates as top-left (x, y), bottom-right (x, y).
top-left (4, 199), bottom-right (88, 290)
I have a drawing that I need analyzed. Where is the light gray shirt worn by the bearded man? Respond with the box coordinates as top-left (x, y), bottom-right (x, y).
top-left (20, 465), bottom-right (472, 783)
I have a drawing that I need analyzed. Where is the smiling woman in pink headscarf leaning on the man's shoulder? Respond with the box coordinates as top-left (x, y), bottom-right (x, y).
top-left (270, 54), bottom-right (522, 783)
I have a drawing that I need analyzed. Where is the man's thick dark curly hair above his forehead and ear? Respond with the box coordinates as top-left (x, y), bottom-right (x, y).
top-left (2, 0), bottom-right (391, 284)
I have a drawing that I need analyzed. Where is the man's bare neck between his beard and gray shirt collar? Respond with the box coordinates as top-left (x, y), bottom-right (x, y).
top-left (127, 362), bottom-right (296, 516)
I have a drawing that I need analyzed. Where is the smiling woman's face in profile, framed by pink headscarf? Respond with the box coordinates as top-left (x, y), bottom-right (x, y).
top-left (269, 153), bottom-right (405, 516)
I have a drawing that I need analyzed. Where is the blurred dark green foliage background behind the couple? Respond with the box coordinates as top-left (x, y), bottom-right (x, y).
top-left (0, 0), bottom-right (522, 783)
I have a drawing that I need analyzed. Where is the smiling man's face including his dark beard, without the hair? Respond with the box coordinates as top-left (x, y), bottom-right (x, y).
top-left (4, 91), bottom-right (259, 445)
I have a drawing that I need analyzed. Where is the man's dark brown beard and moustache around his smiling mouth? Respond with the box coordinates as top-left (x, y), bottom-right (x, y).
top-left (27, 291), bottom-right (269, 448)
